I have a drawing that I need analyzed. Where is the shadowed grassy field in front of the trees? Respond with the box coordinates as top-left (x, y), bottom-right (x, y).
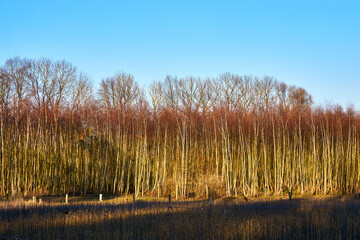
top-left (0, 198), bottom-right (360, 239)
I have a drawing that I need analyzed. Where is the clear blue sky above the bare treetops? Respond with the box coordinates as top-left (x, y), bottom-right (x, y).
top-left (0, 0), bottom-right (360, 109)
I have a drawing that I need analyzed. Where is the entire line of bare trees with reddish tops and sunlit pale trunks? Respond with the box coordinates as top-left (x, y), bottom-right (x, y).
top-left (0, 57), bottom-right (360, 197)
